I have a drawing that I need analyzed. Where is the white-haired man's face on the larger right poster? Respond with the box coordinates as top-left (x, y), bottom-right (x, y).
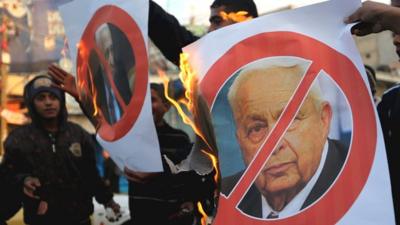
top-left (230, 66), bottom-right (332, 199)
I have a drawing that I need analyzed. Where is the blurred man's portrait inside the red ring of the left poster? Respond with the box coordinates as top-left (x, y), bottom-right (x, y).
top-left (89, 23), bottom-right (135, 124)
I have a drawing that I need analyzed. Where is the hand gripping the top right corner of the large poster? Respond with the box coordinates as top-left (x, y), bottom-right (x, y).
top-left (344, 1), bottom-right (400, 36)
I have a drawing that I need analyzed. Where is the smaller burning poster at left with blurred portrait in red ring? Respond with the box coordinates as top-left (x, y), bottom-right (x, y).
top-left (60, 0), bottom-right (162, 172)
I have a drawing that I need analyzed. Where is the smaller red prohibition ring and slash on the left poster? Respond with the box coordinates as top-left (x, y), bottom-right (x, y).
top-left (77, 5), bottom-right (148, 141)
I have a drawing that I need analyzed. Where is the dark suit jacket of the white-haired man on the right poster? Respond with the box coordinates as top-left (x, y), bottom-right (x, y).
top-left (221, 140), bottom-right (348, 218)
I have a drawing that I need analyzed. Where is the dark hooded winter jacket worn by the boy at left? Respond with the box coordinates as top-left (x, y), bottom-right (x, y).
top-left (3, 76), bottom-right (112, 224)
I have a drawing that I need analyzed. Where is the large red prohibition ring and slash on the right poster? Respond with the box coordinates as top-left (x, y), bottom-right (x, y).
top-left (201, 32), bottom-right (377, 225)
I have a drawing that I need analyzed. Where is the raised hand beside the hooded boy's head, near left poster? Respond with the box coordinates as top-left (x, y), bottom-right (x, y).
top-left (48, 65), bottom-right (79, 99)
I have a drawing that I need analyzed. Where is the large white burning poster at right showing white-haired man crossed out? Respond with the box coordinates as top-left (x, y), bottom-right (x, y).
top-left (185, 0), bottom-right (394, 225)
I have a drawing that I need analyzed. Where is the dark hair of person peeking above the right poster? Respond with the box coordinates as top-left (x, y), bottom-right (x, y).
top-left (210, 0), bottom-right (258, 18)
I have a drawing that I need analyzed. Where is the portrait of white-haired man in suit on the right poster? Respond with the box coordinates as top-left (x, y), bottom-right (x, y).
top-left (221, 63), bottom-right (348, 219)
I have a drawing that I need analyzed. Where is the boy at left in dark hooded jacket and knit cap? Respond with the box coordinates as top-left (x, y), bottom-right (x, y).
top-left (3, 75), bottom-right (119, 225)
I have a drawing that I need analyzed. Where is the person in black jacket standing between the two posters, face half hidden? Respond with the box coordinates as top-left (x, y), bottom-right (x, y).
top-left (125, 83), bottom-right (215, 225)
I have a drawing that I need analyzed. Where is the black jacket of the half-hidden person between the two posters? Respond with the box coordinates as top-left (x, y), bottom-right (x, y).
top-left (129, 121), bottom-right (215, 225)
